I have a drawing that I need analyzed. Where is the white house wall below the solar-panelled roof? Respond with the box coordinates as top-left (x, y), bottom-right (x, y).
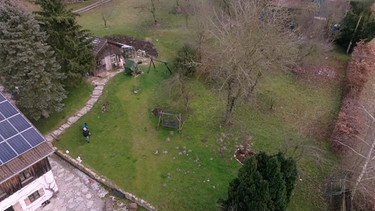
top-left (0, 170), bottom-right (58, 211)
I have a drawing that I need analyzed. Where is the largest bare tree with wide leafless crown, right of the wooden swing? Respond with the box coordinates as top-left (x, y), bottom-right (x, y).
top-left (202, 0), bottom-right (297, 124)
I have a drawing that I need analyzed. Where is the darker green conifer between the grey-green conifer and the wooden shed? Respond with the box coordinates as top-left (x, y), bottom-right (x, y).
top-left (35, 0), bottom-right (95, 87)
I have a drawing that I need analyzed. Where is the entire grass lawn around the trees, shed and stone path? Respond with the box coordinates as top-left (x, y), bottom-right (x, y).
top-left (36, 0), bottom-right (341, 211)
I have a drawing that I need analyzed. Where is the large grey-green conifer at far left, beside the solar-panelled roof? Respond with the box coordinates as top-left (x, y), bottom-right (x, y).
top-left (0, 0), bottom-right (66, 120)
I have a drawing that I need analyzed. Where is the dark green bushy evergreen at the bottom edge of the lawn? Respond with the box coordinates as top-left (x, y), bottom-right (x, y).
top-left (221, 152), bottom-right (297, 211)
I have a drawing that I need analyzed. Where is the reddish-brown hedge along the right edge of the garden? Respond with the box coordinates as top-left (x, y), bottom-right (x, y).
top-left (331, 42), bottom-right (375, 152)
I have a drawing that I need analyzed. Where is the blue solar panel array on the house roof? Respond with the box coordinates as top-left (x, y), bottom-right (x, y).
top-left (0, 93), bottom-right (44, 165)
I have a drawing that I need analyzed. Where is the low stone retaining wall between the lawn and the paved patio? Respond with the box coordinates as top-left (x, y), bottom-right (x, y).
top-left (55, 150), bottom-right (157, 211)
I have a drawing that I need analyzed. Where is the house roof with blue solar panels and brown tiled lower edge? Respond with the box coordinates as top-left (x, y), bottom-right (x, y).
top-left (0, 92), bottom-right (55, 183)
